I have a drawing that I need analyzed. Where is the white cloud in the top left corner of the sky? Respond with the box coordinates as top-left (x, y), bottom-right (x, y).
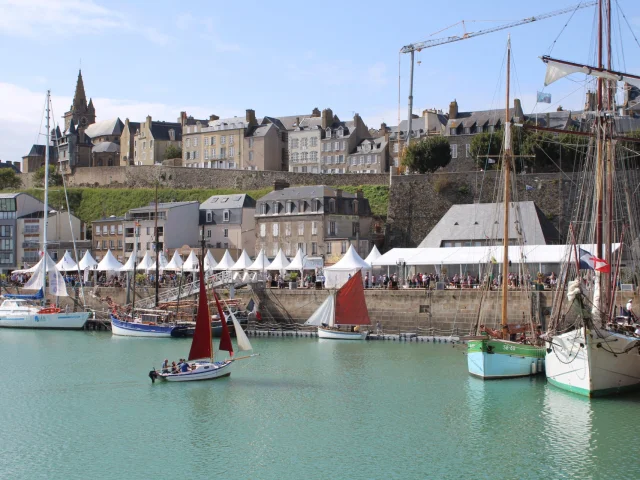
top-left (0, 0), bottom-right (169, 45)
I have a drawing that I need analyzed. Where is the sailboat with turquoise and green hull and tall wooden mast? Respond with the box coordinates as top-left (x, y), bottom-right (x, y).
top-left (467, 37), bottom-right (544, 380)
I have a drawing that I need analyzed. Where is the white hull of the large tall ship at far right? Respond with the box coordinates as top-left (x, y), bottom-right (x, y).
top-left (545, 327), bottom-right (640, 397)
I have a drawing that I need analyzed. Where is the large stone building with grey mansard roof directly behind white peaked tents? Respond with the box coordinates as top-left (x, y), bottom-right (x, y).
top-left (255, 182), bottom-right (372, 264)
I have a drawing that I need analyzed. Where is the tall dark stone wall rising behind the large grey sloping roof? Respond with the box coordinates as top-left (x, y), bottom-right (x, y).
top-left (386, 171), bottom-right (576, 248)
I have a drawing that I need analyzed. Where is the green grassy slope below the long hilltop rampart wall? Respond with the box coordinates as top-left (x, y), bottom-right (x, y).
top-left (25, 185), bottom-right (389, 223)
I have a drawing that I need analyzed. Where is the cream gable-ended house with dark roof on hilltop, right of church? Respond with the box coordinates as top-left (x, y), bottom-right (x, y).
top-left (132, 115), bottom-right (182, 165)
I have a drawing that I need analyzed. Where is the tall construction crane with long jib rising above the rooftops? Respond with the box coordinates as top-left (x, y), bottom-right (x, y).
top-left (398, 1), bottom-right (598, 158)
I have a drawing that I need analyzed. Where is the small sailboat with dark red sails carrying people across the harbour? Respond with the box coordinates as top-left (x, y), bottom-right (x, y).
top-left (149, 265), bottom-right (257, 382)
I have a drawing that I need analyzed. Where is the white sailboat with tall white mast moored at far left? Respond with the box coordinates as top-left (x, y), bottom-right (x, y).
top-left (0, 91), bottom-right (89, 330)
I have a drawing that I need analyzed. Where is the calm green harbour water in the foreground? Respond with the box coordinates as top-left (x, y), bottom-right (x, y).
top-left (0, 330), bottom-right (640, 480)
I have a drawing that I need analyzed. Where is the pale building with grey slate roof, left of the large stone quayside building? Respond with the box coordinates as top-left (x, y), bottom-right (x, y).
top-left (198, 194), bottom-right (256, 255)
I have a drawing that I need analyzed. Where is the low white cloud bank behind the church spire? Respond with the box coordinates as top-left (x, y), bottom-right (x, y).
top-left (0, 82), bottom-right (237, 161)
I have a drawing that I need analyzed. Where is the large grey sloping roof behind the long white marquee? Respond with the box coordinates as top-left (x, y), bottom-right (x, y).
top-left (418, 201), bottom-right (560, 248)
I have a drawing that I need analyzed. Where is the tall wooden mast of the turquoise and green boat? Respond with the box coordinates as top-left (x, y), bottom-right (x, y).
top-left (502, 35), bottom-right (511, 340)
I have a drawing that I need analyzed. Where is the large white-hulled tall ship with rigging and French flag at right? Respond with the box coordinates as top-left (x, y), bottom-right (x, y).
top-left (536, 0), bottom-right (640, 397)
